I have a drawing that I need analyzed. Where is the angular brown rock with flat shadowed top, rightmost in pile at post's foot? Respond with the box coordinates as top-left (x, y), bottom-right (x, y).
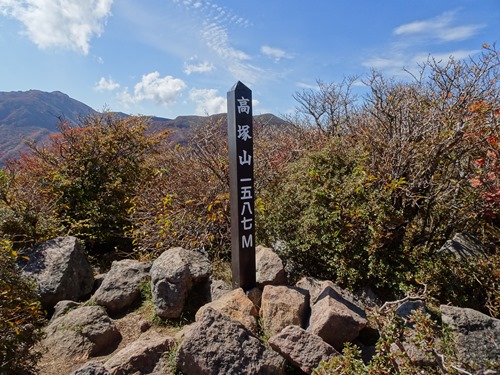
top-left (308, 281), bottom-right (367, 351)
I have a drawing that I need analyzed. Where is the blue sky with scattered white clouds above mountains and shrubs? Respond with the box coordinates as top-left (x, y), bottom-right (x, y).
top-left (0, 0), bottom-right (500, 118)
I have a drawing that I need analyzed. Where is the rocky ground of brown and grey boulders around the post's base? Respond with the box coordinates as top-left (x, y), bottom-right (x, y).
top-left (18, 237), bottom-right (500, 375)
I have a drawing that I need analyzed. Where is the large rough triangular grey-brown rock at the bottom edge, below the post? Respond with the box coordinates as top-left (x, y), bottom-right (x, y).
top-left (177, 308), bottom-right (283, 375)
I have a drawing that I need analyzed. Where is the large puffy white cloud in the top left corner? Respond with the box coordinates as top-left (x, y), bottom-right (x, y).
top-left (0, 0), bottom-right (113, 55)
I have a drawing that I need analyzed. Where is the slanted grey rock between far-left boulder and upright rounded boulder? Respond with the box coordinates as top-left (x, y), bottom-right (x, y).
top-left (92, 259), bottom-right (151, 314)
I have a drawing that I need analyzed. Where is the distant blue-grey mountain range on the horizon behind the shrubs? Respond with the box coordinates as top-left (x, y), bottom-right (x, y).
top-left (0, 90), bottom-right (284, 166)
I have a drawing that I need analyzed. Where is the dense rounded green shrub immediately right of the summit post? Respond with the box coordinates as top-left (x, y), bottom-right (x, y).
top-left (264, 140), bottom-right (408, 287)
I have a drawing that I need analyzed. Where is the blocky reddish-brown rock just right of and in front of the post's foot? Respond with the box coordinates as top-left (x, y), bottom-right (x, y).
top-left (260, 285), bottom-right (309, 336)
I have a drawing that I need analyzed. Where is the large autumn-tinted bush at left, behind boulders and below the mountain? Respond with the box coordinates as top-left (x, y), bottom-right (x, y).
top-left (2, 113), bottom-right (164, 251)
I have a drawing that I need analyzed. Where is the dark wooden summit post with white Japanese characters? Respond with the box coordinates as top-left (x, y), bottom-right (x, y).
top-left (227, 81), bottom-right (256, 291)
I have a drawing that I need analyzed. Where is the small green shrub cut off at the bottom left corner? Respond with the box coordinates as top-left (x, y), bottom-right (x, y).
top-left (0, 240), bottom-right (44, 374)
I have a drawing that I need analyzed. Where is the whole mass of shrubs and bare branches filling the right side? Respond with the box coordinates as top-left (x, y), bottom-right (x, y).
top-left (264, 46), bottom-right (500, 316)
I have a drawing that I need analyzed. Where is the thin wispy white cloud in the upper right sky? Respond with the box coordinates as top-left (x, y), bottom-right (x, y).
top-left (394, 12), bottom-right (483, 42)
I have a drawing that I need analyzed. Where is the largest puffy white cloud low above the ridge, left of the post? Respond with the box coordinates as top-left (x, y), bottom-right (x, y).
top-left (119, 72), bottom-right (187, 105)
